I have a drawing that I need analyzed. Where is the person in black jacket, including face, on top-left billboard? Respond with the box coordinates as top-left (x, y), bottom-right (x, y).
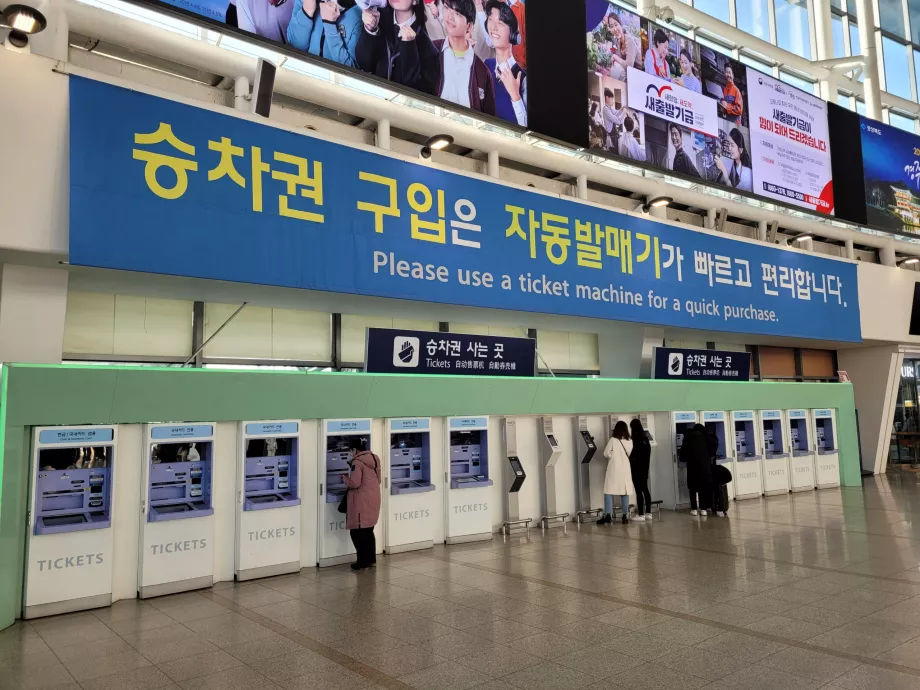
top-left (355, 0), bottom-right (441, 96)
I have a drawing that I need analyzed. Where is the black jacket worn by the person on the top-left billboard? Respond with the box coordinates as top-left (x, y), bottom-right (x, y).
top-left (355, 5), bottom-right (441, 96)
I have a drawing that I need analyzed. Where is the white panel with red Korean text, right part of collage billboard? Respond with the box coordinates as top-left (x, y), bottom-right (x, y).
top-left (748, 71), bottom-right (834, 214)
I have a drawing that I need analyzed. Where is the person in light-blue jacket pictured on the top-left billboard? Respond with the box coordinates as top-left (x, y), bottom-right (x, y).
top-left (287, 0), bottom-right (362, 67)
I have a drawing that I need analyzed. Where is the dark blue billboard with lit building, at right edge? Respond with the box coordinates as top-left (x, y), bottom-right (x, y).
top-left (859, 117), bottom-right (920, 233)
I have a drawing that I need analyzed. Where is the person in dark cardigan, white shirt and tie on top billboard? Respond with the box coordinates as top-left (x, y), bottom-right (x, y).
top-left (436, 0), bottom-right (495, 115)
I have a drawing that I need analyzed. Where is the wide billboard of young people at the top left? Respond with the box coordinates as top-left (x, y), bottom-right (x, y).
top-left (155, 0), bottom-right (527, 127)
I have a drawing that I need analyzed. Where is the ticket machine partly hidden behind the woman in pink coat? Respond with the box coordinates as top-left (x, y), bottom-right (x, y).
top-left (317, 419), bottom-right (374, 568)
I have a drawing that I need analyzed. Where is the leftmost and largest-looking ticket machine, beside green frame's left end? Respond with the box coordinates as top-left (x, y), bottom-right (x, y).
top-left (22, 426), bottom-right (116, 618)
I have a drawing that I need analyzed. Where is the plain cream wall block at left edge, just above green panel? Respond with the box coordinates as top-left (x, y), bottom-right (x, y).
top-left (0, 264), bottom-right (69, 364)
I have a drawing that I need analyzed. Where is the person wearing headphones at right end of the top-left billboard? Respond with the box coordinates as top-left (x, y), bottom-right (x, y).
top-left (486, 0), bottom-right (527, 127)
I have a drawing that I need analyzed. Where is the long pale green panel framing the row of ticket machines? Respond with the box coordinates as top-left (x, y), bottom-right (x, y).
top-left (0, 364), bottom-right (861, 628)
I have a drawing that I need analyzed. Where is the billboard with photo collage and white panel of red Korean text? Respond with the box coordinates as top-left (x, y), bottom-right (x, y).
top-left (586, 0), bottom-right (833, 213)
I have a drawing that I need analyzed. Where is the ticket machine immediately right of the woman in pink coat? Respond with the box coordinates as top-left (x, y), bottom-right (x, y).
top-left (383, 418), bottom-right (435, 553)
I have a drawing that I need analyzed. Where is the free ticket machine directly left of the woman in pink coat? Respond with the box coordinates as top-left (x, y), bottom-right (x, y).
top-left (236, 421), bottom-right (302, 581)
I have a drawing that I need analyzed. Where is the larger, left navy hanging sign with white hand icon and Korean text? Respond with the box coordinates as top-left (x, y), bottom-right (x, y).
top-left (364, 328), bottom-right (537, 376)
